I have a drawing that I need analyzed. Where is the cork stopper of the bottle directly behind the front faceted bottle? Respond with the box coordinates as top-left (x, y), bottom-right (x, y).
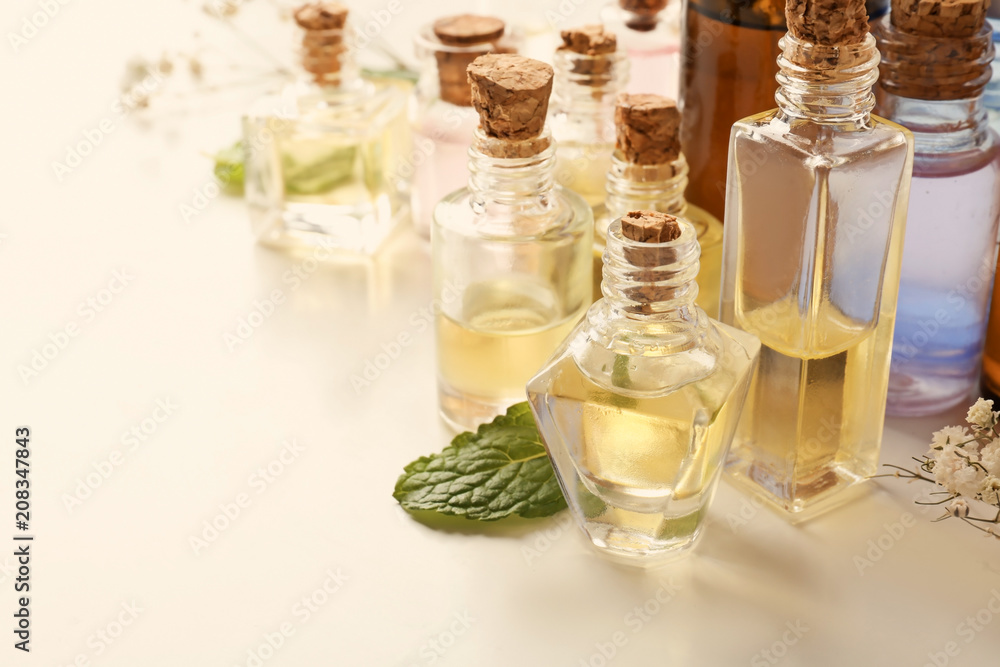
top-left (615, 93), bottom-right (681, 165)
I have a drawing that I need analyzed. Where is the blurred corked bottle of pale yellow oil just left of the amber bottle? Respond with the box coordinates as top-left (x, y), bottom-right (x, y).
top-left (549, 25), bottom-right (628, 206)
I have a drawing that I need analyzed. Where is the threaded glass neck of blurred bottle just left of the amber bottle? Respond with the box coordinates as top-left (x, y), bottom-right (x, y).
top-left (551, 49), bottom-right (629, 124)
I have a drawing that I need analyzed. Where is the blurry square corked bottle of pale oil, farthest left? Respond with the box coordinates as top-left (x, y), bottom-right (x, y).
top-left (243, 3), bottom-right (410, 253)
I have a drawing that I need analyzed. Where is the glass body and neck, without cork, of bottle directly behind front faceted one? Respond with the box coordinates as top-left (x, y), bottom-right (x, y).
top-left (594, 151), bottom-right (722, 317)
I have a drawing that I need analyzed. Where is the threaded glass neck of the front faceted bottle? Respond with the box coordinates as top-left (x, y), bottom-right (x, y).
top-left (601, 218), bottom-right (704, 326)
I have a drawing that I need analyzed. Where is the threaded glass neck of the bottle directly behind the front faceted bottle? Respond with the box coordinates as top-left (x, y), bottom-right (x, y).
top-left (605, 150), bottom-right (688, 218)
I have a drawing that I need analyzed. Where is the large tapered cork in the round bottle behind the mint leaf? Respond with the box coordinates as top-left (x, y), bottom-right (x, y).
top-left (468, 53), bottom-right (552, 157)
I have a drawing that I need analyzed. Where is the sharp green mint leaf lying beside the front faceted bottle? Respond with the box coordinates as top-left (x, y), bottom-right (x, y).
top-left (392, 403), bottom-right (566, 521)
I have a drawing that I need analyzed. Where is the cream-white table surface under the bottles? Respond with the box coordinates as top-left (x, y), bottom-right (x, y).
top-left (7, 0), bottom-right (1000, 667)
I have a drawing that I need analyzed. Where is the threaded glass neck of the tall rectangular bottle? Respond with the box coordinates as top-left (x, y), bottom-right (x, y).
top-left (775, 33), bottom-right (879, 127)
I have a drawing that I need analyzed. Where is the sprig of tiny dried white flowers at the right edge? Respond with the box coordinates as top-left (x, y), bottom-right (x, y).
top-left (876, 398), bottom-right (1000, 539)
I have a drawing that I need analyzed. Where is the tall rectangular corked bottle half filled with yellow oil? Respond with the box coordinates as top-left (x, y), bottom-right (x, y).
top-left (721, 0), bottom-right (913, 520)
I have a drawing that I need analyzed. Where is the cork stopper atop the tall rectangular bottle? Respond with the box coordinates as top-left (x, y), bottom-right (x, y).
top-left (785, 0), bottom-right (868, 46)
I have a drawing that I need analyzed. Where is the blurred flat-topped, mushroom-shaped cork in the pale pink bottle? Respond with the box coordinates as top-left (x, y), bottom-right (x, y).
top-left (431, 14), bottom-right (507, 107)
